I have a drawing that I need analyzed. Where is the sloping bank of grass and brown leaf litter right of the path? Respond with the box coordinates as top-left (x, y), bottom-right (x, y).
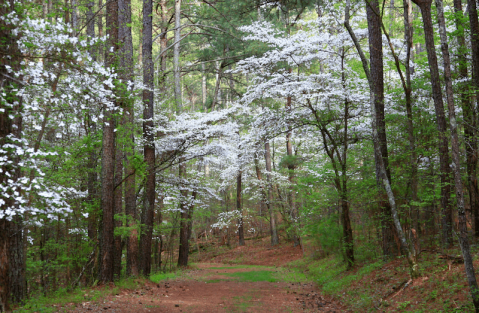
top-left (288, 251), bottom-right (479, 313)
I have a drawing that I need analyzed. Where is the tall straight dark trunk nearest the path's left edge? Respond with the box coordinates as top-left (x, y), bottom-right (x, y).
top-left (140, 0), bottom-right (156, 276)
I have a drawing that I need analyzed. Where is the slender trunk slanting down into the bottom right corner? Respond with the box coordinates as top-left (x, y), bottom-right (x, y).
top-left (436, 0), bottom-right (479, 312)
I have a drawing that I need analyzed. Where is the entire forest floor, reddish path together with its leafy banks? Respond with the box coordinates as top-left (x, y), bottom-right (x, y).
top-left (15, 237), bottom-right (479, 313)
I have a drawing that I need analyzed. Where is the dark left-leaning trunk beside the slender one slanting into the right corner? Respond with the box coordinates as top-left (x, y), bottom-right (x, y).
top-left (413, 0), bottom-right (452, 248)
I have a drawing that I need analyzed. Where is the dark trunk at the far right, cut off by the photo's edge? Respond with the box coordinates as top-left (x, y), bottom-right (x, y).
top-left (466, 0), bottom-right (479, 238)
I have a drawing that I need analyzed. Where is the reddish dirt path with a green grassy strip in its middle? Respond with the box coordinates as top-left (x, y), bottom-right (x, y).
top-left (70, 263), bottom-right (345, 313)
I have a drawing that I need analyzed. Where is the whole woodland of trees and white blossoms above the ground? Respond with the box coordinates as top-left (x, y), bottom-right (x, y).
top-left (0, 0), bottom-right (479, 312)
